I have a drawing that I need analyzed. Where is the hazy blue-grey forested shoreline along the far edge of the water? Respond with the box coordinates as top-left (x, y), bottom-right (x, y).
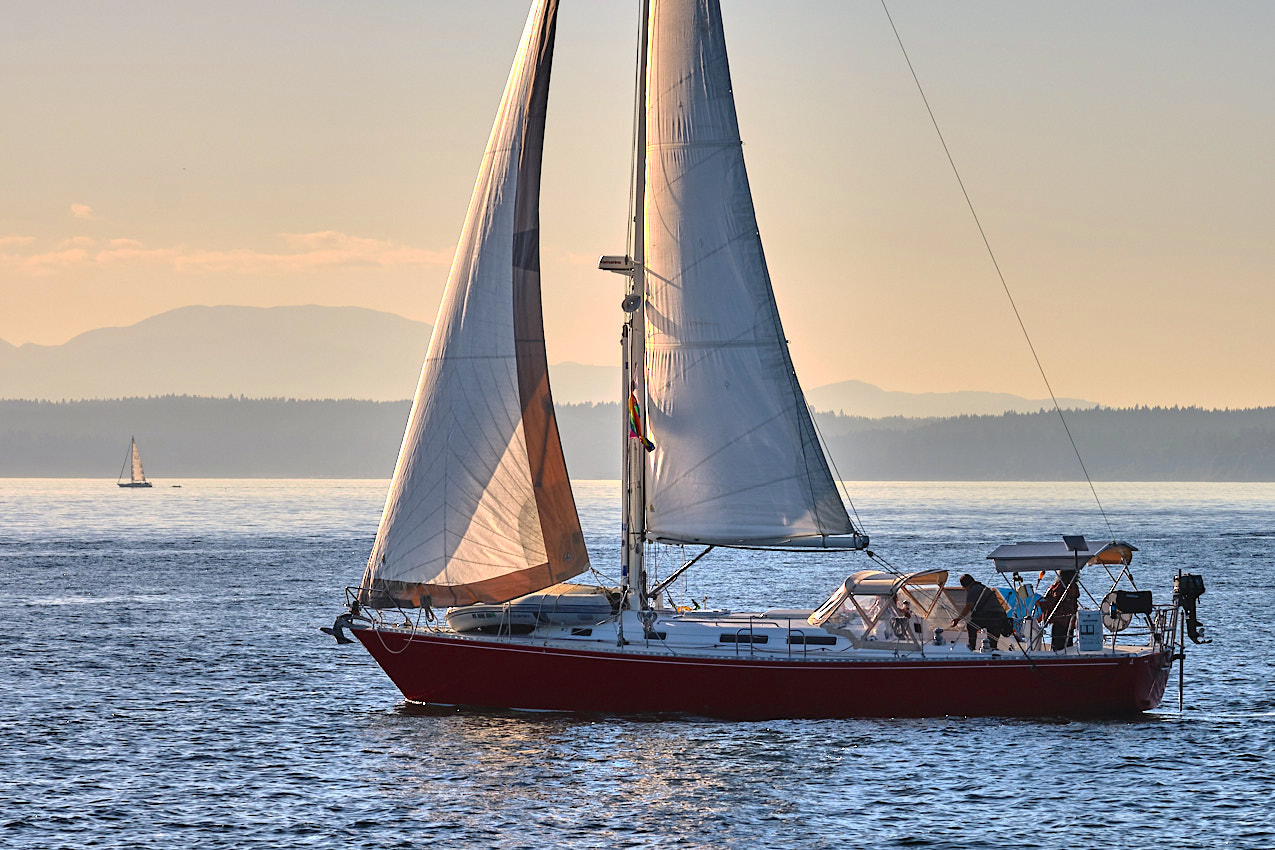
top-left (0, 395), bottom-right (1275, 482)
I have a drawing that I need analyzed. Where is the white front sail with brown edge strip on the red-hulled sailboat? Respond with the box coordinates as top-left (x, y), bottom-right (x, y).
top-left (361, 0), bottom-right (589, 607)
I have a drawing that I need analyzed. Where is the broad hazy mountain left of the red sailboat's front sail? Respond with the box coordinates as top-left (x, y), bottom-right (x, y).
top-left (0, 306), bottom-right (431, 400)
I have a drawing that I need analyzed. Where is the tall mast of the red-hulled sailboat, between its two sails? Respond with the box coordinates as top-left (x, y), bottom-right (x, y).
top-left (620, 0), bottom-right (650, 609)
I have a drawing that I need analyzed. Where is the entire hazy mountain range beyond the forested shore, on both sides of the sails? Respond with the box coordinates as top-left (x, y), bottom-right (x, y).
top-left (0, 306), bottom-right (1094, 418)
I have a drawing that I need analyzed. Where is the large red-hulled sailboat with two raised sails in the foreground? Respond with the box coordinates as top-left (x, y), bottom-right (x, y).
top-left (323, 0), bottom-right (1204, 719)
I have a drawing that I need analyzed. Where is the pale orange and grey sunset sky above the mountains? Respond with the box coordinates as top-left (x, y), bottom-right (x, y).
top-left (0, 0), bottom-right (1275, 407)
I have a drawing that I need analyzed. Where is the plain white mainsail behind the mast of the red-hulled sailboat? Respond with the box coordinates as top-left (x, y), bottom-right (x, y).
top-left (645, 0), bottom-right (853, 545)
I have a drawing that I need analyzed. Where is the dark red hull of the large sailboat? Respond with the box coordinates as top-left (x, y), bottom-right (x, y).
top-left (354, 628), bottom-right (1169, 720)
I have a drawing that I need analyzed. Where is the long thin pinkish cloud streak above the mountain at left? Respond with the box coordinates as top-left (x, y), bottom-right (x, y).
top-left (0, 231), bottom-right (451, 275)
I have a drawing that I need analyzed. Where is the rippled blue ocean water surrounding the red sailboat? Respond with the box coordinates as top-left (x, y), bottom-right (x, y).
top-left (0, 479), bottom-right (1275, 849)
